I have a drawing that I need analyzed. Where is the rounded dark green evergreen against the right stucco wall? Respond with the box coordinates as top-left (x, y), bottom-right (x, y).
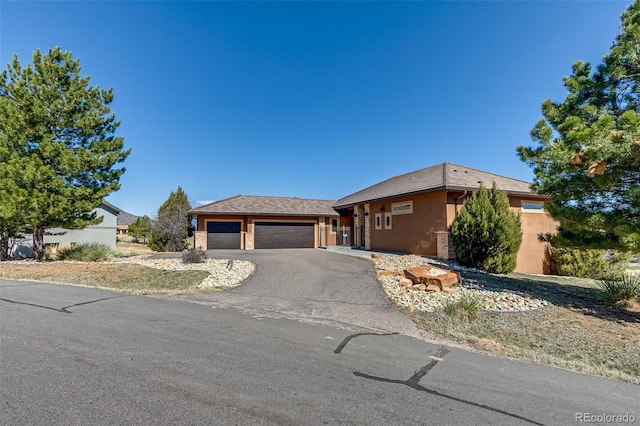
top-left (451, 184), bottom-right (522, 274)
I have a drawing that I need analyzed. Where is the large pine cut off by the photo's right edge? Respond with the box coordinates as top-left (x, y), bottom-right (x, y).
top-left (518, 1), bottom-right (640, 250)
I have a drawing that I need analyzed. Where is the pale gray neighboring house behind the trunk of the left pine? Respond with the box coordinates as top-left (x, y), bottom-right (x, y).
top-left (14, 201), bottom-right (121, 257)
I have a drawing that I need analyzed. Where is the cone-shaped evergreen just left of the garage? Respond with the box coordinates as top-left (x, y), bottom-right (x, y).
top-left (149, 187), bottom-right (192, 251)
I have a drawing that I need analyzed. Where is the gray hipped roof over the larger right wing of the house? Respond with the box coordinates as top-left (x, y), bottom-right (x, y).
top-left (334, 163), bottom-right (536, 208)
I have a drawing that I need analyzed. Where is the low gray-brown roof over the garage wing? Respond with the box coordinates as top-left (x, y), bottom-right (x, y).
top-left (190, 195), bottom-right (338, 216)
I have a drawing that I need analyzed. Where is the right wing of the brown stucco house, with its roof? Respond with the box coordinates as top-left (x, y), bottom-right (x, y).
top-left (334, 163), bottom-right (558, 273)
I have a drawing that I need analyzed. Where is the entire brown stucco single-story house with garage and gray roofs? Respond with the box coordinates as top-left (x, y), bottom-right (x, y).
top-left (190, 163), bottom-right (558, 273)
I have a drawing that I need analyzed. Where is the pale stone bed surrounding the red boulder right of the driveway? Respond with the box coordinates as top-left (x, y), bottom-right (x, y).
top-left (371, 254), bottom-right (549, 312)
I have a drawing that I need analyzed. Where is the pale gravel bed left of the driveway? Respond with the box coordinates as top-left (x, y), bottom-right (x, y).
top-left (114, 257), bottom-right (256, 288)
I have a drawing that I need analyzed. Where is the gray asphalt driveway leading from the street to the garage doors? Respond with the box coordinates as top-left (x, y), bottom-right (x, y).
top-left (176, 249), bottom-right (426, 338)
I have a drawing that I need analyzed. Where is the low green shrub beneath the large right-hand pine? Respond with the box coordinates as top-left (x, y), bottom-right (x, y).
top-left (547, 247), bottom-right (629, 279)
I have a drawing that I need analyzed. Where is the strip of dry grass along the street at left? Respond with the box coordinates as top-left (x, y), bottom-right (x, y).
top-left (0, 262), bottom-right (211, 296)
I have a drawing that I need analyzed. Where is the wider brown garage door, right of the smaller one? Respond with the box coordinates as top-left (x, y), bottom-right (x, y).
top-left (254, 222), bottom-right (314, 249)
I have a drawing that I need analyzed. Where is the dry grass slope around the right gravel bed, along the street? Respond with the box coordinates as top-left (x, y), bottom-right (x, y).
top-left (411, 272), bottom-right (640, 384)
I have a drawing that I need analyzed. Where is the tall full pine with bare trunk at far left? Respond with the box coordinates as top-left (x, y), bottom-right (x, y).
top-left (0, 47), bottom-right (129, 259)
